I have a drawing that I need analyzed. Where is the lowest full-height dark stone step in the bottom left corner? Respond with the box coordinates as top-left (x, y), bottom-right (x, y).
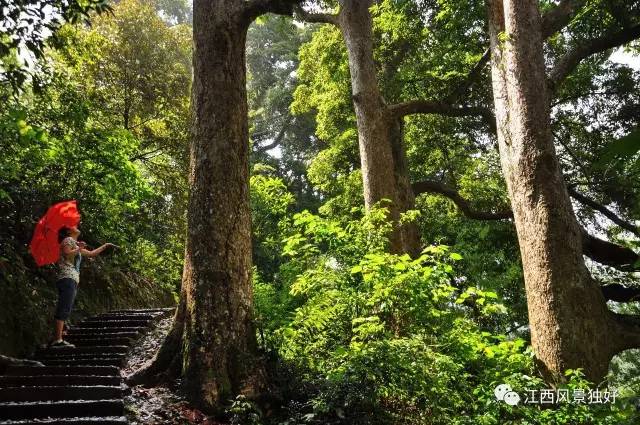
top-left (0, 399), bottom-right (124, 423)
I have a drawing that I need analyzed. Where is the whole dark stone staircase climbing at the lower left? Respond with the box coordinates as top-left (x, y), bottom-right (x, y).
top-left (0, 308), bottom-right (173, 425)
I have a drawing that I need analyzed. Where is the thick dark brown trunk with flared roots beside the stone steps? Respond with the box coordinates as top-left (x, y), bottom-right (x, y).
top-left (129, 0), bottom-right (265, 411)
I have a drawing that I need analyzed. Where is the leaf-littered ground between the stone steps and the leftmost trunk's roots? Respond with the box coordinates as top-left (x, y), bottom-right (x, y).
top-left (122, 316), bottom-right (224, 425)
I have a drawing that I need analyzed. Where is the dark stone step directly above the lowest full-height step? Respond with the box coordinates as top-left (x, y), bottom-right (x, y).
top-left (0, 385), bottom-right (123, 402)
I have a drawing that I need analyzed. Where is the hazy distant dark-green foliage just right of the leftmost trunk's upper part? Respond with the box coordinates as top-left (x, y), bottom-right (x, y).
top-left (247, 15), bottom-right (321, 210)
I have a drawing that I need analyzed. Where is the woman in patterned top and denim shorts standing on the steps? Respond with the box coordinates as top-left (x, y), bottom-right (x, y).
top-left (50, 227), bottom-right (115, 347)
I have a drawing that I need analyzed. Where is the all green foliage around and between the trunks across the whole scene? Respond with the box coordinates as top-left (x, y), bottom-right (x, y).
top-left (0, 0), bottom-right (640, 424)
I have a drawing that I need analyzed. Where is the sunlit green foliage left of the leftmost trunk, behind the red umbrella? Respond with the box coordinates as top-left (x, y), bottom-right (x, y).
top-left (0, 0), bottom-right (190, 302)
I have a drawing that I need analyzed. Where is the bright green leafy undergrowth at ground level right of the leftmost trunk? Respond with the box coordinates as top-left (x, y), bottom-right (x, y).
top-left (242, 172), bottom-right (639, 424)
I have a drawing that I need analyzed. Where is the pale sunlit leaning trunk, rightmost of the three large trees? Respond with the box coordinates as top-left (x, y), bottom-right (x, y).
top-left (488, 0), bottom-right (638, 383)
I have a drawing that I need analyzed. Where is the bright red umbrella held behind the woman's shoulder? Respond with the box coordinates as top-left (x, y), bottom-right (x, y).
top-left (29, 200), bottom-right (80, 266)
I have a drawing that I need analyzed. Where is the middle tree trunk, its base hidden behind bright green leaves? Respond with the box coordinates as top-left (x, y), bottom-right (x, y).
top-left (338, 0), bottom-right (420, 254)
